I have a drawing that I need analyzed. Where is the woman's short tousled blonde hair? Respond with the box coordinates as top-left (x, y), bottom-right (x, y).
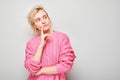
top-left (27, 5), bottom-right (50, 34)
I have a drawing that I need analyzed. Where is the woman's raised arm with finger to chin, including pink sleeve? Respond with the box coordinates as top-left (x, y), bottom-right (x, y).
top-left (24, 28), bottom-right (49, 74)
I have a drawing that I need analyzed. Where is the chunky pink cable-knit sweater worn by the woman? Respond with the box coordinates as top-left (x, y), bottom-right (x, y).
top-left (24, 31), bottom-right (76, 80)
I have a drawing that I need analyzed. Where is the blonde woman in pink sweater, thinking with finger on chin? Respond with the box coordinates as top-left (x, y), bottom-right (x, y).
top-left (24, 6), bottom-right (75, 80)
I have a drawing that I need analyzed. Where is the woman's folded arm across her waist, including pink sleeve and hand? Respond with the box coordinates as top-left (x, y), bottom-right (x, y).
top-left (35, 33), bottom-right (76, 75)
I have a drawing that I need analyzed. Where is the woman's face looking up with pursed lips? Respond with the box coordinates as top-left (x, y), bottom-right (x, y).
top-left (33, 10), bottom-right (51, 33)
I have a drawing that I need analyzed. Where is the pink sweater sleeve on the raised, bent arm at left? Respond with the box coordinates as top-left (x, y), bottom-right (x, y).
top-left (24, 43), bottom-right (41, 73)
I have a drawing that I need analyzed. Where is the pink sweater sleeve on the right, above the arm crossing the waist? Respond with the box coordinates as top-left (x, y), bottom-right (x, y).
top-left (56, 35), bottom-right (76, 73)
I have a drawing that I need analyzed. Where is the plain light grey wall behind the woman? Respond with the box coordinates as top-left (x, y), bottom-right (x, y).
top-left (0, 0), bottom-right (120, 80)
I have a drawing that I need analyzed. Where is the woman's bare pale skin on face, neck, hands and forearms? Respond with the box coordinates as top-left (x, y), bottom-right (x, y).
top-left (32, 10), bottom-right (58, 76)
